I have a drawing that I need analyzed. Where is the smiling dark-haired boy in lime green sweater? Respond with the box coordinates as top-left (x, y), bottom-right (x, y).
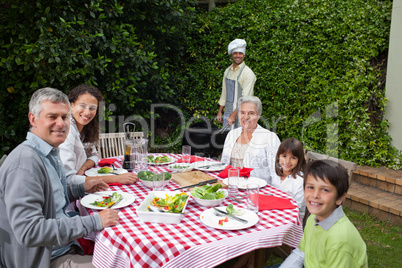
top-left (280, 160), bottom-right (368, 268)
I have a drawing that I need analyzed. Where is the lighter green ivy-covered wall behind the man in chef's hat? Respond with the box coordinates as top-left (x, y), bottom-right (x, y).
top-left (181, 0), bottom-right (401, 168)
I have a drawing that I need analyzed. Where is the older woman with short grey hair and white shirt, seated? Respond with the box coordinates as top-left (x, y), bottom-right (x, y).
top-left (221, 96), bottom-right (280, 184)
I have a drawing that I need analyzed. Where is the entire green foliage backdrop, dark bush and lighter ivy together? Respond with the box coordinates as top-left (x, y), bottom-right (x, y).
top-left (0, 0), bottom-right (401, 168)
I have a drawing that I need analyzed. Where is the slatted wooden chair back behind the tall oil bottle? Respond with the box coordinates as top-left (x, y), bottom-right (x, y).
top-left (97, 132), bottom-right (144, 159)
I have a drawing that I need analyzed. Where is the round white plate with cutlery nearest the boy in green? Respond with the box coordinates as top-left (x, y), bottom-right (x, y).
top-left (200, 207), bottom-right (258, 230)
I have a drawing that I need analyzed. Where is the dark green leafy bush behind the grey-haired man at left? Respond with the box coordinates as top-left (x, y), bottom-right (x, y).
top-left (0, 0), bottom-right (195, 153)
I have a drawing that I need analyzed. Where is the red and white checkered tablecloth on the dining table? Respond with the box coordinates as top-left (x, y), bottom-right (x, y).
top-left (89, 154), bottom-right (303, 268)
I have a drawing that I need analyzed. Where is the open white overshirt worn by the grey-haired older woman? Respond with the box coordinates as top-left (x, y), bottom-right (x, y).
top-left (221, 125), bottom-right (281, 184)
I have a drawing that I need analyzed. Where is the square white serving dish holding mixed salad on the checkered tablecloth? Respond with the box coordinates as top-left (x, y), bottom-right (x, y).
top-left (136, 191), bottom-right (190, 224)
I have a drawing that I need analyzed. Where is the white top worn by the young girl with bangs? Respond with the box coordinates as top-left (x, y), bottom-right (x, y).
top-left (272, 175), bottom-right (306, 220)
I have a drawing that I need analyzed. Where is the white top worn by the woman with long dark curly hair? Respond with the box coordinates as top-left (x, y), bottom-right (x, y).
top-left (59, 117), bottom-right (99, 184)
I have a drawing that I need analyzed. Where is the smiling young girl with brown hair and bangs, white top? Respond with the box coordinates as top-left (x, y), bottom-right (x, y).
top-left (272, 138), bottom-right (306, 220)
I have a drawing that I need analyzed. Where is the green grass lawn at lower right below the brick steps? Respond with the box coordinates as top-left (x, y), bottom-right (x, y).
top-left (267, 207), bottom-right (402, 268)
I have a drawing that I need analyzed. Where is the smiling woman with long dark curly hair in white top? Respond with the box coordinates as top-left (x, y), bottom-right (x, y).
top-left (59, 85), bottom-right (138, 184)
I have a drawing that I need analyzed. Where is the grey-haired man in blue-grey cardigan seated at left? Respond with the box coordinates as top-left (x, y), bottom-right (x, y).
top-left (0, 88), bottom-right (119, 268)
